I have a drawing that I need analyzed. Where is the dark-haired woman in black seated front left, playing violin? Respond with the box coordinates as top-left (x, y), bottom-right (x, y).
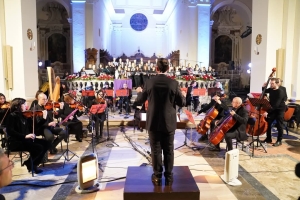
top-left (7, 98), bottom-right (51, 174)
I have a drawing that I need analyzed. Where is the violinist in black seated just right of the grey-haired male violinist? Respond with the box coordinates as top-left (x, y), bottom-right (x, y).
top-left (58, 93), bottom-right (84, 142)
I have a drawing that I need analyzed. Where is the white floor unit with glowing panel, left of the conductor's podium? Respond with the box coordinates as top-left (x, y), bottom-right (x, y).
top-left (75, 153), bottom-right (100, 194)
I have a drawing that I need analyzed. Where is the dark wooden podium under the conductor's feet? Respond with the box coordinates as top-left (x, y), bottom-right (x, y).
top-left (123, 166), bottom-right (200, 200)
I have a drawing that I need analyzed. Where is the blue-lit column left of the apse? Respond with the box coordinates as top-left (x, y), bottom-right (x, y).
top-left (72, 0), bottom-right (85, 72)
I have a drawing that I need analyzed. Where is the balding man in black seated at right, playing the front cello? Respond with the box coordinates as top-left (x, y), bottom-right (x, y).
top-left (209, 97), bottom-right (249, 151)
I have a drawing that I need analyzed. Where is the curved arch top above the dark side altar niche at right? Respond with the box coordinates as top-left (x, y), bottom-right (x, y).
top-left (210, 0), bottom-right (252, 25)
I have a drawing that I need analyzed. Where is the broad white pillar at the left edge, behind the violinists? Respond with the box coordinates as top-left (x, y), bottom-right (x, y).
top-left (1, 0), bottom-right (38, 99)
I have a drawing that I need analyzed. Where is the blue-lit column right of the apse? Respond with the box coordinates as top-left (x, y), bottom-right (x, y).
top-left (197, 2), bottom-right (210, 68)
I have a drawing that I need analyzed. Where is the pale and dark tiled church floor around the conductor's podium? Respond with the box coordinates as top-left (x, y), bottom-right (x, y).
top-left (0, 112), bottom-right (300, 200)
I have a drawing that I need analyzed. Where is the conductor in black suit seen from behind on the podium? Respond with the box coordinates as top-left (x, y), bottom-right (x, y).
top-left (136, 58), bottom-right (186, 185)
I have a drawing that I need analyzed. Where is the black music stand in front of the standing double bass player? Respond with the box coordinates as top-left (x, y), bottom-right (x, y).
top-left (249, 98), bottom-right (271, 157)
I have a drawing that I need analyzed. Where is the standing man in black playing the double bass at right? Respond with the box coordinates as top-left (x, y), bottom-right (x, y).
top-left (263, 78), bottom-right (286, 147)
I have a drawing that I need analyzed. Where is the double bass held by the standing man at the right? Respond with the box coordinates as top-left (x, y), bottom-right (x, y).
top-left (245, 68), bottom-right (276, 136)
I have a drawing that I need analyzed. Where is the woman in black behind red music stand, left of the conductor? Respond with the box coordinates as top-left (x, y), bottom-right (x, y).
top-left (92, 90), bottom-right (107, 140)
